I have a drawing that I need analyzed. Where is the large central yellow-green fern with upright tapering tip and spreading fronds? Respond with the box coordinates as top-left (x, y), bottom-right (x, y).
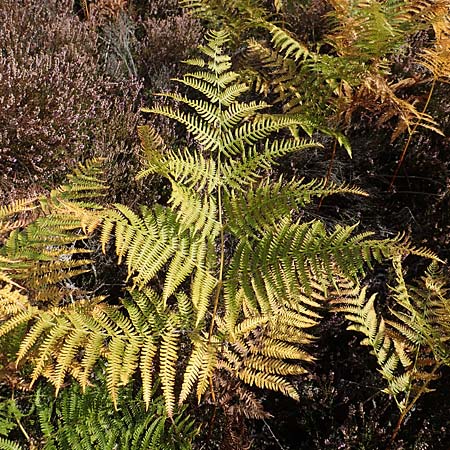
top-left (0, 32), bottom-right (440, 416)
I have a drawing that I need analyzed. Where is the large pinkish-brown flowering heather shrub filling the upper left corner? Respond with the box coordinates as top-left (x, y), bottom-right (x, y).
top-left (0, 0), bottom-right (139, 201)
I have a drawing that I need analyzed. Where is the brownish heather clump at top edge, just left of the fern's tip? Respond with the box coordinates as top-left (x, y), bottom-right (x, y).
top-left (79, 0), bottom-right (203, 91)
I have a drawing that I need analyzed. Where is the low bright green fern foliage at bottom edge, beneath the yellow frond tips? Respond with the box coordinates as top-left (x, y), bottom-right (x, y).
top-left (36, 385), bottom-right (196, 450)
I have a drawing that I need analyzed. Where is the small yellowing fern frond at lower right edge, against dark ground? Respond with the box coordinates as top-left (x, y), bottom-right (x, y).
top-left (332, 252), bottom-right (449, 411)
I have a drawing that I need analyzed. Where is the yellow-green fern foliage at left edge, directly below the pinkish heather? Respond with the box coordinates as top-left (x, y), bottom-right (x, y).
top-left (0, 157), bottom-right (105, 306)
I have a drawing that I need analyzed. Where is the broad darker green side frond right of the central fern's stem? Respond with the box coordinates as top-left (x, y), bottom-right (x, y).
top-left (227, 220), bottom-right (391, 301)
